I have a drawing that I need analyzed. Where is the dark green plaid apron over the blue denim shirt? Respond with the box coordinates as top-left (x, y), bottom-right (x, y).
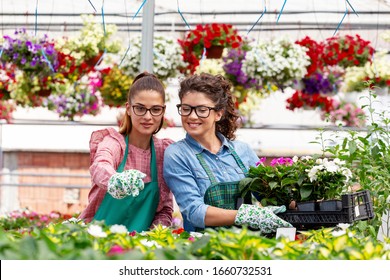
top-left (195, 146), bottom-right (252, 231)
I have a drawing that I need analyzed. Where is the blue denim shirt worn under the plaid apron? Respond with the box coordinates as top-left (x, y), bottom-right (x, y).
top-left (164, 134), bottom-right (259, 231)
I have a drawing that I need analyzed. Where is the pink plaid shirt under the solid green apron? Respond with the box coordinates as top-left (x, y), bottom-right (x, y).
top-left (80, 128), bottom-right (173, 226)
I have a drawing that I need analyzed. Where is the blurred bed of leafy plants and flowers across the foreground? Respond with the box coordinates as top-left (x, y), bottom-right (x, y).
top-left (0, 210), bottom-right (390, 260)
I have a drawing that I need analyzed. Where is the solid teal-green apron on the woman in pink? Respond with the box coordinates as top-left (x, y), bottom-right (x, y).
top-left (94, 136), bottom-right (159, 232)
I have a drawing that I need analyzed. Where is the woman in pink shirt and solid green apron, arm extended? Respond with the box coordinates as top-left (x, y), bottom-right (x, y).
top-left (80, 72), bottom-right (173, 232)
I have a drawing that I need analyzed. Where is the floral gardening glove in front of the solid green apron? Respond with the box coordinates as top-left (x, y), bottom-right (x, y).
top-left (107, 169), bottom-right (146, 199)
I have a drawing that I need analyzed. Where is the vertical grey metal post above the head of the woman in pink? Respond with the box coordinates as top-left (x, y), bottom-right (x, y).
top-left (140, 0), bottom-right (155, 73)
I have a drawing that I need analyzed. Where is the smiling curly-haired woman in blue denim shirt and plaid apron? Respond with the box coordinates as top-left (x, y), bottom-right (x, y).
top-left (164, 74), bottom-right (291, 233)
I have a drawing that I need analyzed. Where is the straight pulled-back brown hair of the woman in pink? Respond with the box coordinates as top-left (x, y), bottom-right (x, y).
top-left (119, 71), bottom-right (165, 135)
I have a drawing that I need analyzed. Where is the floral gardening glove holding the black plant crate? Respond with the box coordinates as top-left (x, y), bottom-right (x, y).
top-left (234, 204), bottom-right (292, 233)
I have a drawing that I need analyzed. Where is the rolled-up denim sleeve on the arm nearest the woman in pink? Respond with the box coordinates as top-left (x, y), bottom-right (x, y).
top-left (164, 144), bottom-right (208, 228)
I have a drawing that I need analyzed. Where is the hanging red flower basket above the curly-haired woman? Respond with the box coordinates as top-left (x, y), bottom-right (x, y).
top-left (178, 23), bottom-right (242, 74)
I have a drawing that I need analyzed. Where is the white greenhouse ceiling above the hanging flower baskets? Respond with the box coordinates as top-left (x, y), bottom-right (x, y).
top-left (0, 0), bottom-right (390, 49)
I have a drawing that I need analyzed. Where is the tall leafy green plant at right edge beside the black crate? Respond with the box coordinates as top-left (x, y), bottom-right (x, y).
top-left (319, 82), bottom-right (390, 235)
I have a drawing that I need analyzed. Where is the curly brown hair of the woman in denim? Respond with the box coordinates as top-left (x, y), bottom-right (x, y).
top-left (179, 73), bottom-right (240, 140)
